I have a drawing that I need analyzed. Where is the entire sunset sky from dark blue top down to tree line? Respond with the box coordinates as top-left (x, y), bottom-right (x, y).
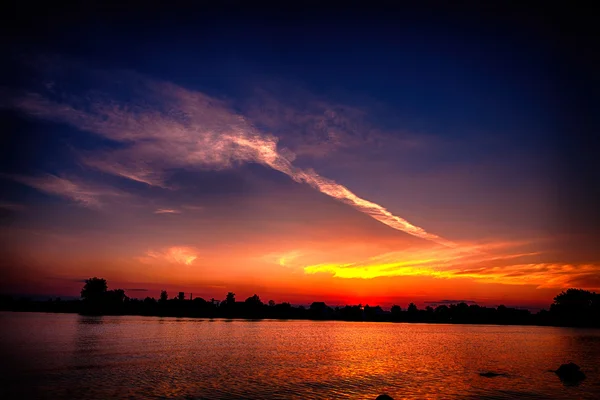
top-left (0, 2), bottom-right (600, 308)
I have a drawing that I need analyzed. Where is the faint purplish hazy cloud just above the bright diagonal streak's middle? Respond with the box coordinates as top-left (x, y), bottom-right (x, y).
top-left (242, 81), bottom-right (430, 158)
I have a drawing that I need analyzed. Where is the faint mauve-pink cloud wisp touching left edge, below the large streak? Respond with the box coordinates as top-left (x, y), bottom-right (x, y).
top-left (4, 174), bottom-right (125, 208)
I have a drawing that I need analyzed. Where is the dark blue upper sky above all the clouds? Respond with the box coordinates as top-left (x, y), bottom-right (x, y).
top-left (3, 2), bottom-right (598, 231)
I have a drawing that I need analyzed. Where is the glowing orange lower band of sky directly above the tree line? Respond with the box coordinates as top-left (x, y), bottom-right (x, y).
top-left (2, 177), bottom-right (598, 307)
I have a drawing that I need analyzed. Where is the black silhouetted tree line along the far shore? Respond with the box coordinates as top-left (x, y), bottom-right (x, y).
top-left (0, 277), bottom-right (600, 327)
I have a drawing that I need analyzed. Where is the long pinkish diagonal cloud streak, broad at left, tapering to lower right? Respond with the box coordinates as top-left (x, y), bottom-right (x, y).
top-left (7, 67), bottom-right (454, 246)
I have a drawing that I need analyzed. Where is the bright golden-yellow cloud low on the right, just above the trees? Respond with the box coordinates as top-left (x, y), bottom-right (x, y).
top-left (303, 239), bottom-right (600, 289)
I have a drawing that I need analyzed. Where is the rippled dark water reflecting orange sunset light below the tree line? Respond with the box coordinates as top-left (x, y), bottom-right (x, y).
top-left (0, 313), bottom-right (600, 399)
